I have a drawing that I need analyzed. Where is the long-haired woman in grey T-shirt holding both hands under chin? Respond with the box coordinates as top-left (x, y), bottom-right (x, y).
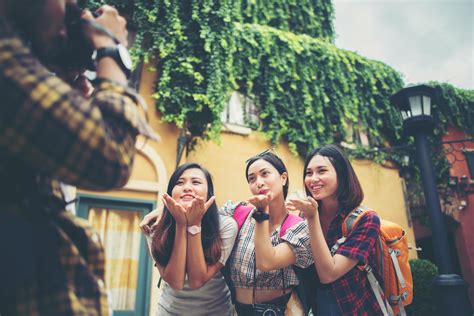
top-left (140, 163), bottom-right (237, 316)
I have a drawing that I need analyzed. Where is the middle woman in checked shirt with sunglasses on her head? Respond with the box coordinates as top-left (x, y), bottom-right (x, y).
top-left (221, 151), bottom-right (313, 315)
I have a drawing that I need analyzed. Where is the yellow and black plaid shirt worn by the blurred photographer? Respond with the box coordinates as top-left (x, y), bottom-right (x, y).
top-left (0, 19), bottom-right (155, 316)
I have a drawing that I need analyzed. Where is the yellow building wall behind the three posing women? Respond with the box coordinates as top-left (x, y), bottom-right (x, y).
top-left (78, 65), bottom-right (416, 315)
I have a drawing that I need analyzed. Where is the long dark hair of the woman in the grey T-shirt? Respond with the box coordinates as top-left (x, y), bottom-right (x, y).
top-left (152, 163), bottom-right (222, 266)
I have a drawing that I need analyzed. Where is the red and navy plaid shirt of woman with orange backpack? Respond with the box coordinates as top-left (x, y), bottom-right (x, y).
top-left (326, 211), bottom-right (383, 316)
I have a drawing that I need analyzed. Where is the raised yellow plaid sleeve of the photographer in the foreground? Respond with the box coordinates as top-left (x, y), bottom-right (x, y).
top-left (0, 33), bottom-right (158, 190)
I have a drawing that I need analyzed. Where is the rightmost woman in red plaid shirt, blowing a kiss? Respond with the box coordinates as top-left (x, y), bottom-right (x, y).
top-left (287, 145), bottom-right (382, 316)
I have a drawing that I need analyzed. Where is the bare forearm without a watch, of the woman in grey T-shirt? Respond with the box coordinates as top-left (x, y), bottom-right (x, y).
top-left (161, 225), bottom-right (187, 290)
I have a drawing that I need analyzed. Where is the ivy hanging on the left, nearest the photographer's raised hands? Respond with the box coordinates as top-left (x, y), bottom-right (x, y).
top-left (88, 0), bottom-right (236, 139)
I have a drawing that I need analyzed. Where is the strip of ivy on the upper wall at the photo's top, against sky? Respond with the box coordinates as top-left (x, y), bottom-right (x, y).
top-left (236, 0), bottom-right (334, 42)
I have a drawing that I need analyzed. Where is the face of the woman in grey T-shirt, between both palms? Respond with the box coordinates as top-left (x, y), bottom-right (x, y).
top-left (171, 168), bottom-right (208, 207)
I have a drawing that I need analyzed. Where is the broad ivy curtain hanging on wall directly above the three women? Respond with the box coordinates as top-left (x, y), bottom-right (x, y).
top-left (234, 24), bottom-right (402, 154)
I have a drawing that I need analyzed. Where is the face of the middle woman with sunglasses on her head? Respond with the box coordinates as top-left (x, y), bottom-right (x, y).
top-left (247, 159), bottom-right (288, 199)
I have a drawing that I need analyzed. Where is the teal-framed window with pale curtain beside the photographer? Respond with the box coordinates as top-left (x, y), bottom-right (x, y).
top-left (77, 194), bottom-right (155, 316)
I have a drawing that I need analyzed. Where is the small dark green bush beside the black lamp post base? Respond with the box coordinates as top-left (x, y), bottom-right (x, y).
top-left (407, 259), bottom-right (438, 316)
